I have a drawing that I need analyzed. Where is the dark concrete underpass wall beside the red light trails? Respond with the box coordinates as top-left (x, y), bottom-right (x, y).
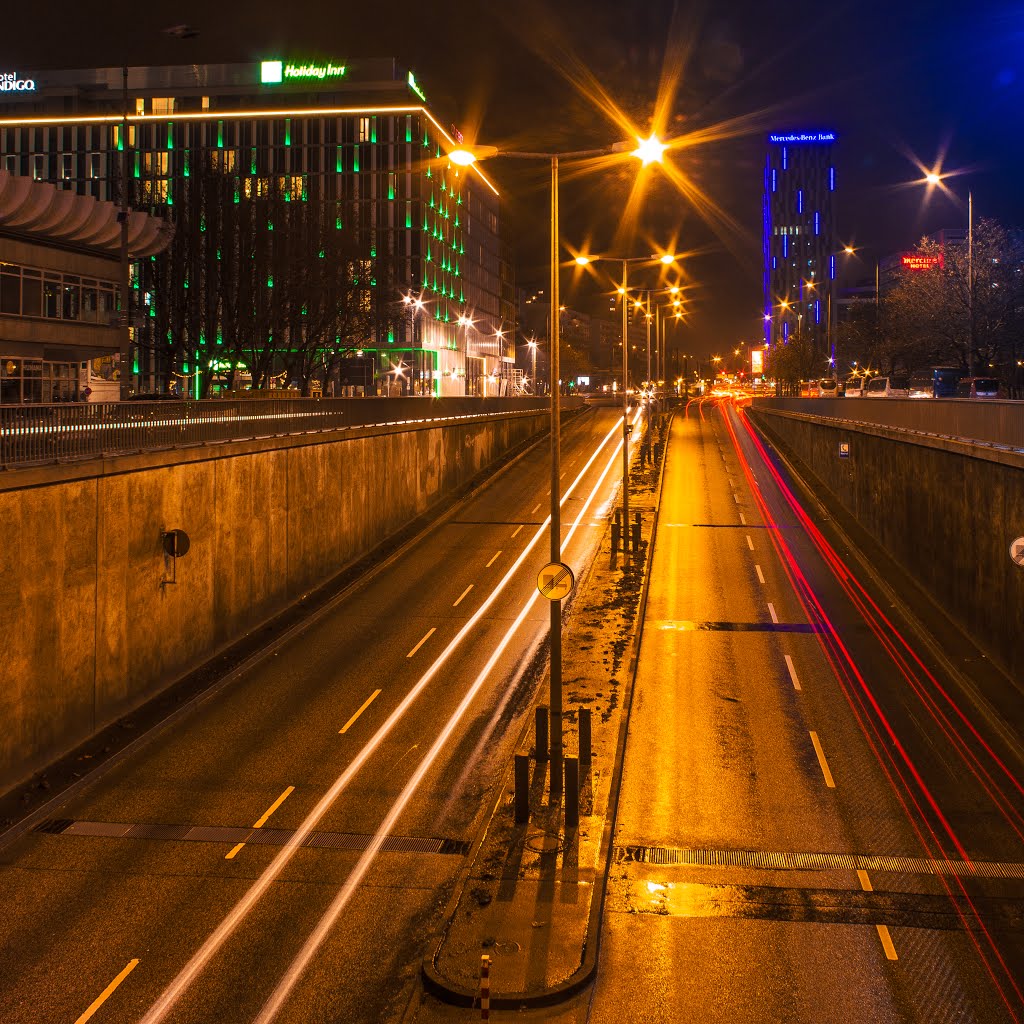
top-left (750, 408), bottom-right (1024, 680)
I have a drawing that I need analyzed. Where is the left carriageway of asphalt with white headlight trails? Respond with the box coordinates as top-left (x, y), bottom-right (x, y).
top-left (0, 410), bottom-right (621, 1024)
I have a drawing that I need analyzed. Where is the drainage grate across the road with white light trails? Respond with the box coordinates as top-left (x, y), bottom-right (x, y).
top-left (35, 818), bottom-right (470, 857)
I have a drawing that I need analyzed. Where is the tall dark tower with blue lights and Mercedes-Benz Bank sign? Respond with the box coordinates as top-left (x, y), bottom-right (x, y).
top-left (762, 131), bottom-right (836, 356)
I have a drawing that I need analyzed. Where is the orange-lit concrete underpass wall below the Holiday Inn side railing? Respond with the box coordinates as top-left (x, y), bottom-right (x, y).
top-left (0, 412), bottom-right (549, 792)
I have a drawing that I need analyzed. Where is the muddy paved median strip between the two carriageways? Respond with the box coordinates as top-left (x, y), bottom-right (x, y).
top-left (423, 405), bottom-right (671, 1009)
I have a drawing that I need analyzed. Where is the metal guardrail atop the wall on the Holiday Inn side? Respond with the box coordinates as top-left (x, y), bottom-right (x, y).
top-left (0, 397), bottom-right (582, 469)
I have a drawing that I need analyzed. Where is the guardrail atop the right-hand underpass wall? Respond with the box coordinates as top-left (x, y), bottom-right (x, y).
top-left (752, 398), bottom-right (1024, 449)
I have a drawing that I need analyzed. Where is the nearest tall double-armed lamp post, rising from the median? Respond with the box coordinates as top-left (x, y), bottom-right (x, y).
top-left (447, 135), bottom-right (666, 798)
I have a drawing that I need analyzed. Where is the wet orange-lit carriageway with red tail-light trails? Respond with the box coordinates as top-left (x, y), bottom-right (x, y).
top-left (585, 403), bottom-right (1024, 1024)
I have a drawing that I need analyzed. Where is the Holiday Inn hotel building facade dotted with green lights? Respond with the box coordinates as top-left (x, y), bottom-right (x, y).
top-left (0, 59), bottom-right (514, 395)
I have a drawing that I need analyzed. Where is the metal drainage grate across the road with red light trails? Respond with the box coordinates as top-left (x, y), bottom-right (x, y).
top-left (615, 846), bottom-right (1024, 879)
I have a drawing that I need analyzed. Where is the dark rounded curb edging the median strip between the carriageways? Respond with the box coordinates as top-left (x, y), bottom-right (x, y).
top-left (421, 409), bottom-right (677, 1010)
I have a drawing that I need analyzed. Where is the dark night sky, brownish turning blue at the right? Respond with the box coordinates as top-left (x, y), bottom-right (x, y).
top-left (9, 0), bottom-right (1024, 353)
